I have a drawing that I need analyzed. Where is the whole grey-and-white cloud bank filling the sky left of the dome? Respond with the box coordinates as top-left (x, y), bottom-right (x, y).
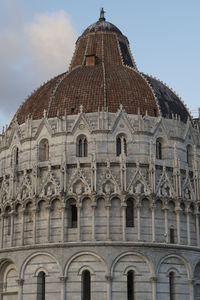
top-left (0, 9), bottom-right (77, 126)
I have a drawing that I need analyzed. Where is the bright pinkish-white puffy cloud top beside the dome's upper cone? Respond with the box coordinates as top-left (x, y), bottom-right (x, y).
top-left (27, 11), bottom-right (76, 76)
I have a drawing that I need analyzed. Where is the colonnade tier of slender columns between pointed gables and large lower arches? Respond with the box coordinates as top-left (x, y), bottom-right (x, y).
top-left (0, 196), bottom-right (200, 248)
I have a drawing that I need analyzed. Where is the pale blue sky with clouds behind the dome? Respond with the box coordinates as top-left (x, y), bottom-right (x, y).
top-left (0, 0), bottom-right (200, 126)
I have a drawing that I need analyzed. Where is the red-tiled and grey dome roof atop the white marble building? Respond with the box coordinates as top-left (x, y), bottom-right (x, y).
top-left (11, 18), bottom-right (191, 124)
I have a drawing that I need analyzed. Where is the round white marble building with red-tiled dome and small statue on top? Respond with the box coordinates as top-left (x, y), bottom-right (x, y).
top-left (0, 11), bottom-right (200, 300)
